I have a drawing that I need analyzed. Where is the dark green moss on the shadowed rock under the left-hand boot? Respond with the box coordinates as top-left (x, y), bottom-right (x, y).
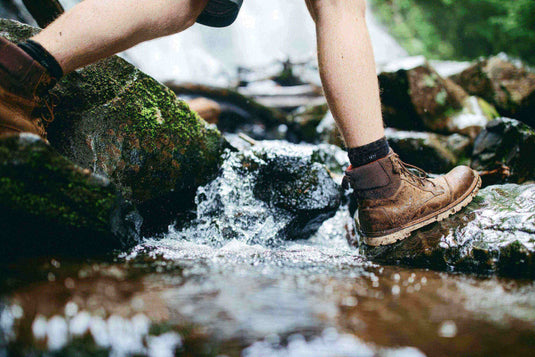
top-left (0, 136), bottom-right (116, 230)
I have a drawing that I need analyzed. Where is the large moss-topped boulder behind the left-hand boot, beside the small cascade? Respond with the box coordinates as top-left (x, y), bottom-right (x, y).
top-left (0, 20), bottom-right (224, 229)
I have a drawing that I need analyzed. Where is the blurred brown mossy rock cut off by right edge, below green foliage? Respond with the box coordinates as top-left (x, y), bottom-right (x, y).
top-left (451, 56), bottom-right (535, 126)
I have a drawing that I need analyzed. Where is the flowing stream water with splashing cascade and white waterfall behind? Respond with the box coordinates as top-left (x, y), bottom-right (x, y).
top-left (0, 0), bottom-right (535, 357)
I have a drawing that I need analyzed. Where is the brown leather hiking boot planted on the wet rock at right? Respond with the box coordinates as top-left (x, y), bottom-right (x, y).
top-left (344, 151), bottom-right (481, 246)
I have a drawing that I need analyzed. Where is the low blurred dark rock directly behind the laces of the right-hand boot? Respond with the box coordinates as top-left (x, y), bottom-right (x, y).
top-left (385, 128), bottom-right (471, 173)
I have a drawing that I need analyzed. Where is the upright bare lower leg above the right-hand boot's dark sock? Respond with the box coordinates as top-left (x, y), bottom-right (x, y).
top-left (305, 0), bottom-right (384, 148)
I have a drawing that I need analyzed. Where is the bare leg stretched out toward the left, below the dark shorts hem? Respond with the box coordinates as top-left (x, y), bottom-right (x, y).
top-left (28, 0), bottom-right (208, 73)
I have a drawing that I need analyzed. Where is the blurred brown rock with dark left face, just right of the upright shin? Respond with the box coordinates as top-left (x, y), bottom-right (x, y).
top-left (379, 59), bottom-right (497, 137)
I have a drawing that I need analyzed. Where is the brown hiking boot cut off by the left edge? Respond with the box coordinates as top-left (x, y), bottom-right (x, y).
top-left (0, 37), bottom-right (56, 140)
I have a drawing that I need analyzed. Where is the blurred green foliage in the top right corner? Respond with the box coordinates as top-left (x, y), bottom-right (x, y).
top-left (371, 0), bottom-right (535, 64)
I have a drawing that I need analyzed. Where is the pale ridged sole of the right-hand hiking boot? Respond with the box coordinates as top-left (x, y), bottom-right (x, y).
top-left (364, 172), bottom-right (481, 247)
